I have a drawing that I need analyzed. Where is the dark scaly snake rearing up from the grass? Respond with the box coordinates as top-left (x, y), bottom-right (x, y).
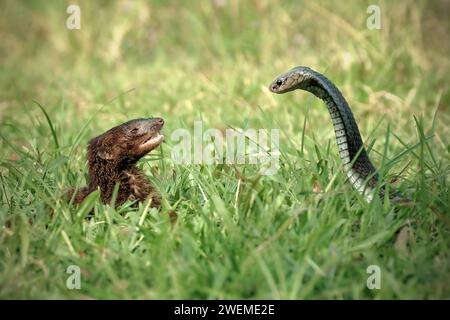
top-left (269, 66), bottom-right (406, 202)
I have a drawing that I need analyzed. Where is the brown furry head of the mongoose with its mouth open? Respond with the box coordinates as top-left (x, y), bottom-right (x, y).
top-left (88, 118), bottom-right (164, 162)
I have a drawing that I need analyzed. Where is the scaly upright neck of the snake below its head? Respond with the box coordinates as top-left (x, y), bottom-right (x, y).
top-left (298, 70), bottom-right (384, 202)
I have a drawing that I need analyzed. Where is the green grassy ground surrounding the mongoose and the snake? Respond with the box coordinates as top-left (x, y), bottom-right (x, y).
top-left (0, 0), bottom-right (450, 299)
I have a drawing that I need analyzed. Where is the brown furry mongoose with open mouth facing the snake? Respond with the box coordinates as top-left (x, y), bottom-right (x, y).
top-left (68, 118), bottom-right (164, 208)
